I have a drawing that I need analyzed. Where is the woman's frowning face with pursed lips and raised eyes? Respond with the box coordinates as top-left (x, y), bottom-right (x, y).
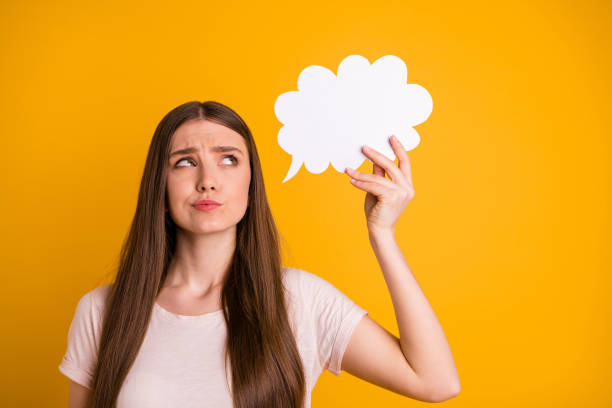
top-left (167, 119), bottom-right (251, 234)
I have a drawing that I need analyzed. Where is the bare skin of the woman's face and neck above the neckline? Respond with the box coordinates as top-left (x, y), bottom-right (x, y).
top-left (157, 119), bottom-right (251, 315)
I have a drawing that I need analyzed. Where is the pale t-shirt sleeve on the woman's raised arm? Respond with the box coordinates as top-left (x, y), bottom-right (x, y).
top-left (302, 271), bottom-right (368, 376)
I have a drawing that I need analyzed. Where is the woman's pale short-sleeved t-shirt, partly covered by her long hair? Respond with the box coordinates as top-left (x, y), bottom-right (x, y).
top-left (59, 267), bottom-right (368, 408)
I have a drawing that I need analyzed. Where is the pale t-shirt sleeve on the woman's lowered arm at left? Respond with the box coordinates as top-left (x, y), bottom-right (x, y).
top-left (59, 289), bottom-right (100, 389)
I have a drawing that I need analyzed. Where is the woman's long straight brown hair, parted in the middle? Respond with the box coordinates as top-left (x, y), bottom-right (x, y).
top-left (89, 101), bottom-right (305, 408)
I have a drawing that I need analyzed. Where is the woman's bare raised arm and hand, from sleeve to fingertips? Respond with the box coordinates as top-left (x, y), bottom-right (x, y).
top-left (341, 136), bottom-right (461, 402)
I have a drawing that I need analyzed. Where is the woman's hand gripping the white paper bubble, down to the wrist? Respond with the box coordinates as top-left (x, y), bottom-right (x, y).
top-left (345, 135), bottom-right (414, 234)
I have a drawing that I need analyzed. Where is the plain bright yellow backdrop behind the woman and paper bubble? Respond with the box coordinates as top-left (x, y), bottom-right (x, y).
top-left (0, 0), bottom-right (612, 408)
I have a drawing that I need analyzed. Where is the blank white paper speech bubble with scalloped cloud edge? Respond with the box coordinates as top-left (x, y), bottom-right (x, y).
top-left (274, 55), bottom-right (433, 183)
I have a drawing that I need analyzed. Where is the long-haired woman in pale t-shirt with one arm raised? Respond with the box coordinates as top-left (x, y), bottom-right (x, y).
top-left (59, 101), bottom-right (460, 408)
